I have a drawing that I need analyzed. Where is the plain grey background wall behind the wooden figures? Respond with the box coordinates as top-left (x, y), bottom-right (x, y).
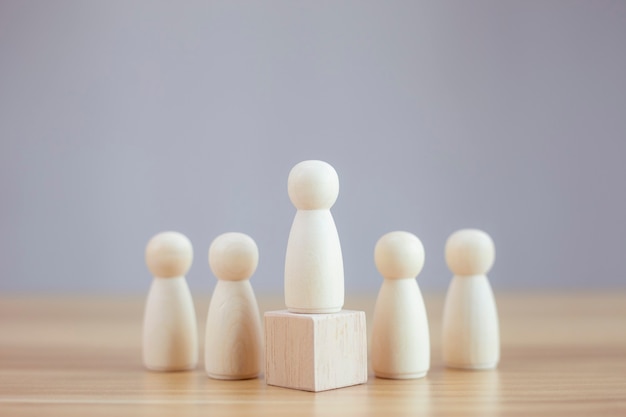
top-left (0, 0), bottom-right (626, 293)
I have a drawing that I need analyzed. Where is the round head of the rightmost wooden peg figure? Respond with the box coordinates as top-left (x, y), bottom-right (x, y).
top-left (446, 229), bottom-right (496, 275)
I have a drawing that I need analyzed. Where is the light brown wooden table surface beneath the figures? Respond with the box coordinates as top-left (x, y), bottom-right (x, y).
top-left (0, 292), bottom-right (626, 417)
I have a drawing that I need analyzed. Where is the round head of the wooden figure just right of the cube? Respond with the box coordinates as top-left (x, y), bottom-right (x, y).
top-left (374, 231), bottom-right (424, 279)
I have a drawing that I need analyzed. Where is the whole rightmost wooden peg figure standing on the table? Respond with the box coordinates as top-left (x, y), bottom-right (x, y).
top-left (442, 229), bottom-right (500, 369)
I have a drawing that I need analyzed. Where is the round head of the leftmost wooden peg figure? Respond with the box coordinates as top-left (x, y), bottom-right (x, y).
top-left (146, 232), bottom-right (193, 278)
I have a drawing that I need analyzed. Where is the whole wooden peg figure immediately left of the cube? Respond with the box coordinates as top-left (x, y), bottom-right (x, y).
top-left (204, 233), bottom-right (263, 379)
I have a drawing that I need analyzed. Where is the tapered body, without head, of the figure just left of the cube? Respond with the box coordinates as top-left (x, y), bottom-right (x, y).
top-left (204, 280), bottom-right (263, 379)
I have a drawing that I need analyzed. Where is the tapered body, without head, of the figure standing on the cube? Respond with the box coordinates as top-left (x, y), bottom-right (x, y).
top-left (285, 210), bottom-right (344, 313)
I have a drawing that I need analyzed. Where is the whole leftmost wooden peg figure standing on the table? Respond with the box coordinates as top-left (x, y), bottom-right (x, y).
top-left (143, 232), bottom-right (198, 371)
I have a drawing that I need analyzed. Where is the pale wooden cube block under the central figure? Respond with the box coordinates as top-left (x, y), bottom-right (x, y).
top-left (265, 310), bottom-right (367, 392)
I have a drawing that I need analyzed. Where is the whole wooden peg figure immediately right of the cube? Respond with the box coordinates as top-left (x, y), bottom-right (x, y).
top-left (372, 232), bottom-right (430, 379)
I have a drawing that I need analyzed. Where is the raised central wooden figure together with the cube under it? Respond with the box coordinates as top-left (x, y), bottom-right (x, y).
top-left (265, 161), bottom-right (367, 392)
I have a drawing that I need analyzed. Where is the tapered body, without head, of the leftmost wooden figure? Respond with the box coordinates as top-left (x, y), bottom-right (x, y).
top-left (143, 277), bottom-right (198, 371)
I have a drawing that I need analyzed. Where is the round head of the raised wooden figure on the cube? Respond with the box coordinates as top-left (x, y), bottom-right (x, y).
top-left (287, 161), bottom-right (339, 210)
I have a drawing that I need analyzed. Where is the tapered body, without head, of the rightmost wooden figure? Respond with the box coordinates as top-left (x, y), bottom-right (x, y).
top-left (442, 275), bottom-right (500, 369)
